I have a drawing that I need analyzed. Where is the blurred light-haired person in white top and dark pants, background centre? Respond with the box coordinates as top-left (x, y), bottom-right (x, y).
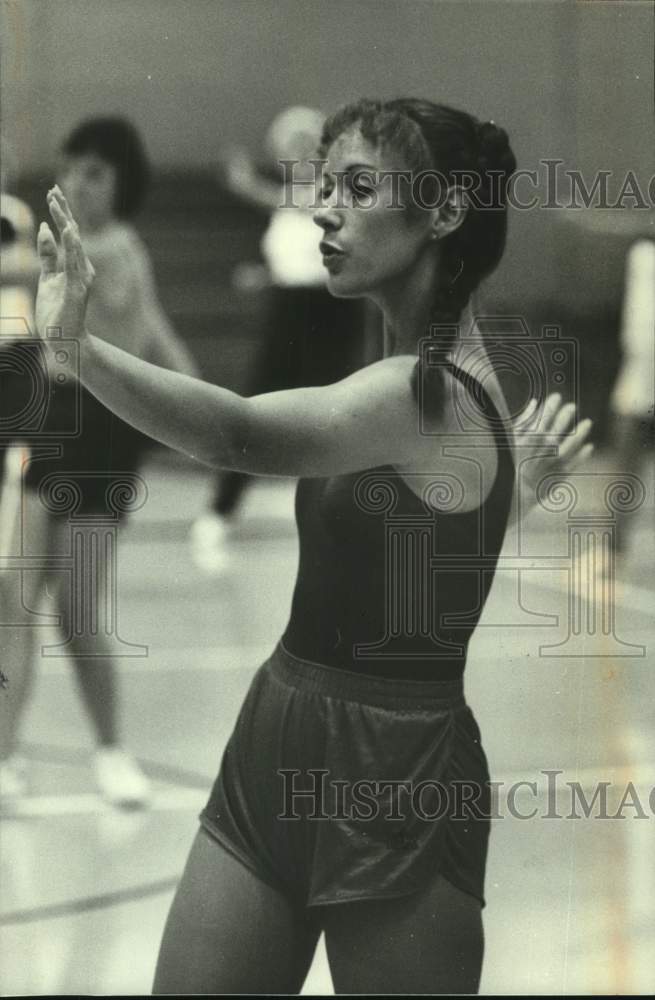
top-left (191, 106), bottom-right (366, 574)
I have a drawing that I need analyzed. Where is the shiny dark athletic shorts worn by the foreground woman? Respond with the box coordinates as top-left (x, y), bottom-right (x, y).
top-left (200, 644), bottom-right (490, 906)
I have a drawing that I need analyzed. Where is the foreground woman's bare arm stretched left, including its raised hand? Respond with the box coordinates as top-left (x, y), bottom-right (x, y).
top-left (36, 189), bottom-right (421, 477)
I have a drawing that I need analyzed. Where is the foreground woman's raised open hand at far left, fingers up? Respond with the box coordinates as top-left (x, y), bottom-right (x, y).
top-left (36, 186), bottom-right (95, 340)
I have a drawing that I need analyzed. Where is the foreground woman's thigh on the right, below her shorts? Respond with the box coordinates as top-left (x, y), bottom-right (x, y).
top-left (322, 875), bottom-right (484, 994)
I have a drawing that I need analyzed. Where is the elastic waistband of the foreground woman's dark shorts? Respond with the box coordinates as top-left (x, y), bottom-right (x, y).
top-left (269, 642), bottom-right (466, 711)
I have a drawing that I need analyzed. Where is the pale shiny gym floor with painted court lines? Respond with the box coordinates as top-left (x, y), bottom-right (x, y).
top-left (0, 455), bottom-right (655, 995)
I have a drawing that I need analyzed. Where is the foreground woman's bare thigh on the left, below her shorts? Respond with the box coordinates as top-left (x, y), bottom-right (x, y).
top-left (153, 827), bottom-right (319, 995)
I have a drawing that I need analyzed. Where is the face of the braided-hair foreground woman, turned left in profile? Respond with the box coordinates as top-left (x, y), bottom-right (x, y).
top-left (314, 128), bottom-right (432, 298)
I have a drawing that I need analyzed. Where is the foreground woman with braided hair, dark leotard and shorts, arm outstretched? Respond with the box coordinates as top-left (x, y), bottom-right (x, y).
top-left (37, 100), bottom-right (584, 994)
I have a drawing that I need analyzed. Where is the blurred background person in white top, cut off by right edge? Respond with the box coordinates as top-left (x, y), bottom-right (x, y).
top-left (611, 239), bottom-right (655, 560)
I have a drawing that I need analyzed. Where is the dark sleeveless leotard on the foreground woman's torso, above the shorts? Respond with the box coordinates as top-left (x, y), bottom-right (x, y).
top-left (282, 365), bottom-right (514, 680)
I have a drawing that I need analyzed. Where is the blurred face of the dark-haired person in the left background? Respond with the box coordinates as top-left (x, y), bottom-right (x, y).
top-left (59, 153), bottom-right (116, 230)
